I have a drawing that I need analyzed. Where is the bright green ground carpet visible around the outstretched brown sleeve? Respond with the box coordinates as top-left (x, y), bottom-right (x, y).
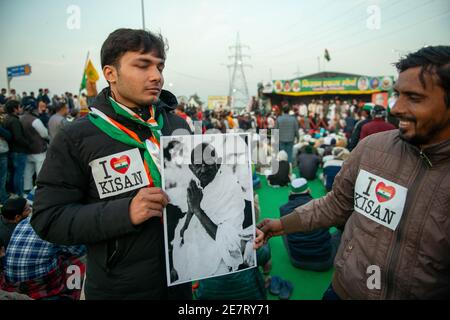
top-left (255, 171), bottom-right (333, 300)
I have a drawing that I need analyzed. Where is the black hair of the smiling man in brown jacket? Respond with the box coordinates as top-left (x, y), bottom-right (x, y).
top-left (395, 46), bottom-right (450, 108)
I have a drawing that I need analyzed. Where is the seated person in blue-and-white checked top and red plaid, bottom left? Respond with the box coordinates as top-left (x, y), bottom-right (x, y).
top-left (0, 217), bottom-right (86, 300)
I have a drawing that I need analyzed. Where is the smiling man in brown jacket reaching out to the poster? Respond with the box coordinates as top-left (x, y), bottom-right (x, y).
top-left (259, 46), bottom-right (450, 299)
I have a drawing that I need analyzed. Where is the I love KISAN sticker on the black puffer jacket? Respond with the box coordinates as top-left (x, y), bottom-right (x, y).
top-left (89, 148), bottom-right (150, 199)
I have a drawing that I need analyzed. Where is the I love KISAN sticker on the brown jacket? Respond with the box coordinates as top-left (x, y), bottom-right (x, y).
top-left (354, 170), bottom-right (408, 230)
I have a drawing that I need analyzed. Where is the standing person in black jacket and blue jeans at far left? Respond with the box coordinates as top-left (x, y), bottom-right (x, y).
top-left (3, 100), bottom-right (31, 196)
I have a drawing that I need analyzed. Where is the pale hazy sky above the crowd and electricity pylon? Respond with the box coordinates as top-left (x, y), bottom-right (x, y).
top-left (0, 0), bottom-right (450, 100)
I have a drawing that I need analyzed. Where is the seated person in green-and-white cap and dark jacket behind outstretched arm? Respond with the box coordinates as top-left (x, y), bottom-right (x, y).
top-left (280, 178), bottom-right (340, 271)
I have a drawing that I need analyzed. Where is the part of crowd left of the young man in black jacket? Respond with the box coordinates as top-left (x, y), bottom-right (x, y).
top-left (0, 89), bottom-right (85, 299)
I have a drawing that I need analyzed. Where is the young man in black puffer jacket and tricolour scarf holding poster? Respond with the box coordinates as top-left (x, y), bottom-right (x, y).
top-left (31, 29), bottom-right (191, 300)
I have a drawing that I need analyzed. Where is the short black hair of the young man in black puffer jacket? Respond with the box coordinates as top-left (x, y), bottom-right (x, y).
top-left (100, 28), bottom-right (167, 68)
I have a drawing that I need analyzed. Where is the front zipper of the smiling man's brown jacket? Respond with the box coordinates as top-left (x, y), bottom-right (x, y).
top-left (384, 150), bottom-right (433, 300)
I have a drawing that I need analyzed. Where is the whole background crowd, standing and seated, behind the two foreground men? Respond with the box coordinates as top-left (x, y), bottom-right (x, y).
top-left (0, 79), bottom-right (406, 299)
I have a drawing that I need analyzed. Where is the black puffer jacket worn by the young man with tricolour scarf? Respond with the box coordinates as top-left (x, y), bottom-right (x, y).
top-left (31, 88), bottom-right (191, 299)
